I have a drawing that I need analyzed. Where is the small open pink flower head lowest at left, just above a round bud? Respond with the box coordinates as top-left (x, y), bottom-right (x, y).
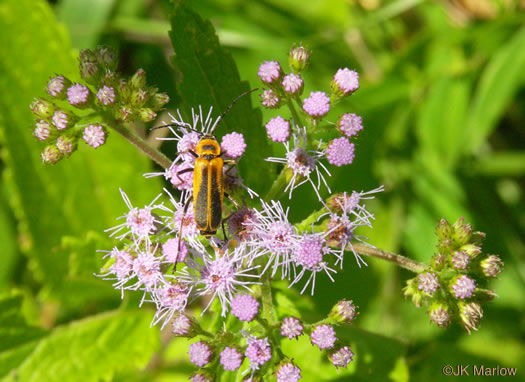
top-left (153, 283), bottom-right (191, 330)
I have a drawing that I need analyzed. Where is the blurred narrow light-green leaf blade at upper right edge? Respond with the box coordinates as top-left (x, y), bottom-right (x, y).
top-left (465, 28), bottom-right (525, 153)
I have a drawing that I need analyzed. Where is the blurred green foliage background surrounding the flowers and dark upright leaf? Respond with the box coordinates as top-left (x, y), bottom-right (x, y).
top-left (0, 0), bottom-right (525, 381)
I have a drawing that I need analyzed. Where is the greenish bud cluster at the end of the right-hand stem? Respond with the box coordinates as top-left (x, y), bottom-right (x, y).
top-left (404, 218), bottom-right (503, 333)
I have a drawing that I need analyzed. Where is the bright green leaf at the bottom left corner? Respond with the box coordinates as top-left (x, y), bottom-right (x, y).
top-left (6, 311), bottom-right (160, 382)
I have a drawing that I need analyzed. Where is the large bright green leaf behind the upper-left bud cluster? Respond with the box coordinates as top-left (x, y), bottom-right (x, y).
top-left (0, 0), bottom-right (160, 285)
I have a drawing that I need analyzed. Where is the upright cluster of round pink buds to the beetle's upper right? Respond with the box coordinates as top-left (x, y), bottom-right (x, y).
top-left (258, 46), bottom-right (363, 201)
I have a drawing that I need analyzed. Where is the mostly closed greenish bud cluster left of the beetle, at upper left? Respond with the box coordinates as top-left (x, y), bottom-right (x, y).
top-left (30, 46), bottom-right (169, 164)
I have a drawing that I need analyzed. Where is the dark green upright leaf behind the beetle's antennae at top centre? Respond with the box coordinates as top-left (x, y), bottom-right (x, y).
top-left (170, 3), bottom-right (271, 194)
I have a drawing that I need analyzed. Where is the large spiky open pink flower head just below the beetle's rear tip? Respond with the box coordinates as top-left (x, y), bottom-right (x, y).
top-left (178, 246), bottom-right (259, 316)
